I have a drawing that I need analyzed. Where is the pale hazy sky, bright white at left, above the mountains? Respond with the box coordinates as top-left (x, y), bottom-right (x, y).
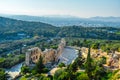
top-left (0, 0), bottom-right (120, 17)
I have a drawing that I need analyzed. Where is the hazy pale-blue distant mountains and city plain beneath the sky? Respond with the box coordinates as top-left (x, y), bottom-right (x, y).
top-left (0, 15), bottom-right (120, 27)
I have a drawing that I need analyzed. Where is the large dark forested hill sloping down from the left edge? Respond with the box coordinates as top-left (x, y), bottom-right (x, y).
top-left (0, 17), bottom-right (58, 40)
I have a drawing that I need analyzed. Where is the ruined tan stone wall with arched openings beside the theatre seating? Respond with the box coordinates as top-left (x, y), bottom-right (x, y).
top-left (25, 39), bottom-right (66, 66)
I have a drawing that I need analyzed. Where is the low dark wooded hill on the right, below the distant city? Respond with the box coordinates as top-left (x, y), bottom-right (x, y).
top-left (59, 26), bottom-right (120, 40)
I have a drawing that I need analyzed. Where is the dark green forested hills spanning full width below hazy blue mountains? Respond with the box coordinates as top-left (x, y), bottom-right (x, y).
top-left (0, 17), bottom-right (120, 41)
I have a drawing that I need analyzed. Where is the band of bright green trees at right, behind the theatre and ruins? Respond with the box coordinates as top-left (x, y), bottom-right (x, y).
top-left (66, 38), bottom-right (120, 53)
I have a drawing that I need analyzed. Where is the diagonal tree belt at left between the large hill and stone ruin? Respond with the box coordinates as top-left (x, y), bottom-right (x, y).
top-left (0, 36), bottom-right (47, 54)
